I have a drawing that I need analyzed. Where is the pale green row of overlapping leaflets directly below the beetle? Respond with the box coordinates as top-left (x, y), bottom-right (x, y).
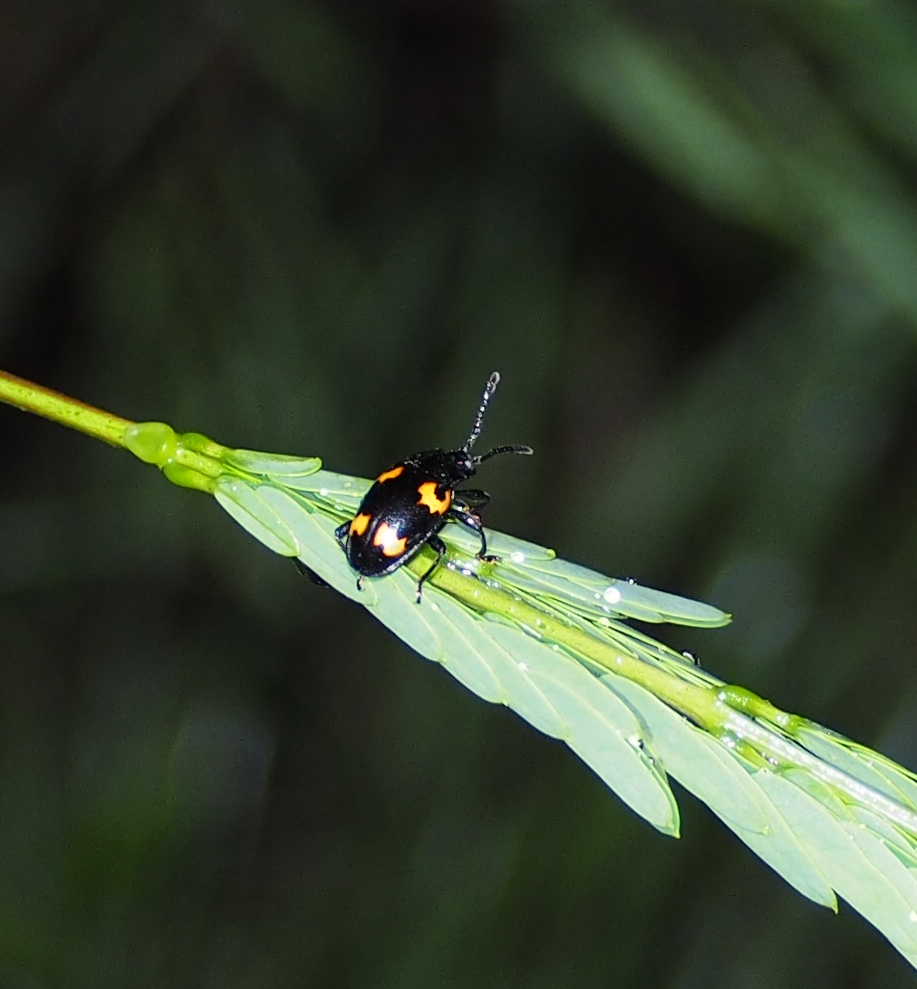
top-left (217, 475), bottom-right (678, 834)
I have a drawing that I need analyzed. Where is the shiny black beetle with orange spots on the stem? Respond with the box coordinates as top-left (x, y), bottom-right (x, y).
top-left (335, 371), bottom-right (533, 604)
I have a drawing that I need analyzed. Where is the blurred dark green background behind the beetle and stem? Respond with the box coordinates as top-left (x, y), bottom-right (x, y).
top-left (0, 0), bottom-right (917, 989)
